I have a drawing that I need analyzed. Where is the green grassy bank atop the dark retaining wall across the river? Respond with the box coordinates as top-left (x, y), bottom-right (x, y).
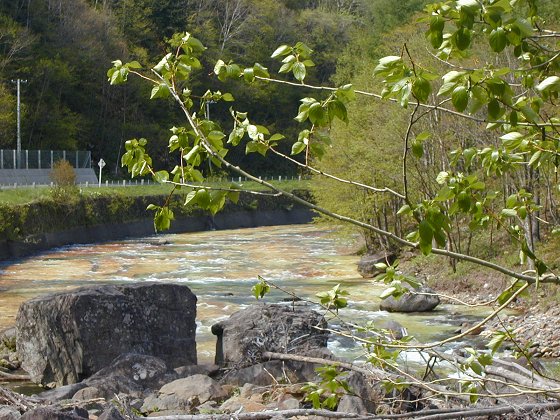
top-left (0, 181), bottom-right (308, 241)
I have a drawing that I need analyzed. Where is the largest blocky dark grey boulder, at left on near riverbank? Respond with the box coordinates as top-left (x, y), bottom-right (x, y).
top-left (16, 283), bottom-right (196, 386)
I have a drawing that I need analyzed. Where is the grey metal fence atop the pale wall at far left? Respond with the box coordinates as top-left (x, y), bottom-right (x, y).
top-left (0, 149), bottom-right (91, 169)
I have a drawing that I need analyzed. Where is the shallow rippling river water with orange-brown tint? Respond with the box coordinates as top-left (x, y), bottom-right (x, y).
top-left (0, 225), bottom-right (488, 370)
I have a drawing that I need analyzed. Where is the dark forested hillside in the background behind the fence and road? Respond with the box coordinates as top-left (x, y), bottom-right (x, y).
top-left (0, 0), bottom-right (426, 175)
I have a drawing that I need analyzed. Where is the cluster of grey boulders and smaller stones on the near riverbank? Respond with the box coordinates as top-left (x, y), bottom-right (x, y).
top-left (0, 283), bottom-right (392, 420)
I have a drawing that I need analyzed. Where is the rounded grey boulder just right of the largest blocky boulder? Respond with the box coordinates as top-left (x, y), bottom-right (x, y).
top-left (212, 304), bottom-right (328, 367)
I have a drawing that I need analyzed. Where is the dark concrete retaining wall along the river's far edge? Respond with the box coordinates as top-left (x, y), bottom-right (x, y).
top-left (0, 208), bottom-right (315, 261)
